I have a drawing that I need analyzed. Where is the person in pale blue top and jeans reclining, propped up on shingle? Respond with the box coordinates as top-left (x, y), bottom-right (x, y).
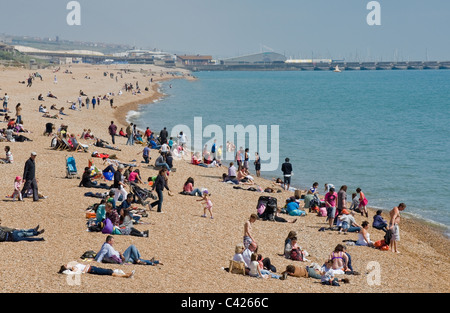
top-left (95, 235), bottom-right (163, 266)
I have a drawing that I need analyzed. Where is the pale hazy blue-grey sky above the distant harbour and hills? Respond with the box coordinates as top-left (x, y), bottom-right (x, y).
top-left (0, 0), bottom-right (450, 61)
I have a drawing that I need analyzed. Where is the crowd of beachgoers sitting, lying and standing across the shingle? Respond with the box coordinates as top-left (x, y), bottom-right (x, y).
top-left (0, 67), bottom-right (406, 286)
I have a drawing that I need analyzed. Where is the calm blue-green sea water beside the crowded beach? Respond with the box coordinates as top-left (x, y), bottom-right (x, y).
top-left (129, 70), bottom-right (450, 234)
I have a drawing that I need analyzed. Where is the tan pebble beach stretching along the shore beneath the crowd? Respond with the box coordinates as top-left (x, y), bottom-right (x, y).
top-left (0, 64), bottom-right (450, 293)
